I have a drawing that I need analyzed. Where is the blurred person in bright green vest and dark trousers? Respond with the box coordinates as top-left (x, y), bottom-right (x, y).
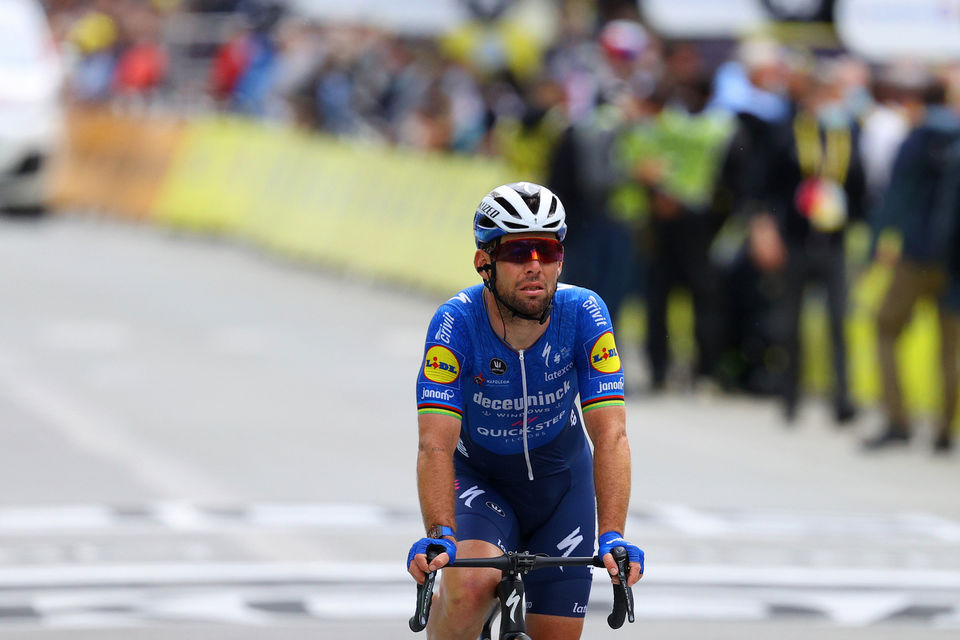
top-left (621, 77), bottom-right (733, 389)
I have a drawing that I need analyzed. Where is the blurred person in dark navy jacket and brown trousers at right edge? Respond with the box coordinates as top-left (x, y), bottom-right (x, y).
top-left (864, 81), bottom-right (960, 451)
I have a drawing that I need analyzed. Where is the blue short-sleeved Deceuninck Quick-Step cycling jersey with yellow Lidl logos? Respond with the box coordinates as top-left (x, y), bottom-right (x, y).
top-left (417, 284), bottom-right (624, 480)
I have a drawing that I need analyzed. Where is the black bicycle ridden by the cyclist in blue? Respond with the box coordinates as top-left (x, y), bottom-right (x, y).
top-left (409, 545), bottom-right (634, 640)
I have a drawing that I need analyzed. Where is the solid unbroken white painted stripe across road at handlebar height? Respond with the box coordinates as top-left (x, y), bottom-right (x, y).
top-left (0, 563), bottom-right (960, 591)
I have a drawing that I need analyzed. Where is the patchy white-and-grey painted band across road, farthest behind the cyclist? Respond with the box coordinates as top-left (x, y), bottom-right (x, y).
top-left (0, 501), bottom-right (960, 544)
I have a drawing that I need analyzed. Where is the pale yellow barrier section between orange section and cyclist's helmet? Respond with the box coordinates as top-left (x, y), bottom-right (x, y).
top-left (155, 118), bottom-right (508, 293)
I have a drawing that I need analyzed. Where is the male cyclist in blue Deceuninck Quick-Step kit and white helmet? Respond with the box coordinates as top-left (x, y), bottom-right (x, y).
top-left (407, 182), bottom-right (643, 640)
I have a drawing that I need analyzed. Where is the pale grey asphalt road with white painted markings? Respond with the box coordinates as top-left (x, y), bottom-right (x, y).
top-left (0, 216), bottom-right (960, 640)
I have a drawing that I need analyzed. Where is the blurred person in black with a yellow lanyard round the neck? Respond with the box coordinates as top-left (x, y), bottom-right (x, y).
top-left (770, 62), bottom-right (865, 424)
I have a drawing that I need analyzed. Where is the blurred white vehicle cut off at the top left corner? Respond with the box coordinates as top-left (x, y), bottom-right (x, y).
top-left (0, 0), bottom-right (63, 209)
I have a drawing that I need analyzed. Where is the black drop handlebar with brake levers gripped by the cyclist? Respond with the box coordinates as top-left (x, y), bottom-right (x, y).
top-left (410, 545), bottom-right (634, 631)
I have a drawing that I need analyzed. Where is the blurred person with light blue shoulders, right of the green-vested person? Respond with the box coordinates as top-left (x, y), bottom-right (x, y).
top-left (709, 40), bottom-right (792, 394)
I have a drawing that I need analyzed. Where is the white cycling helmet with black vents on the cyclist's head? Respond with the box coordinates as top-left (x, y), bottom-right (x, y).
top-left (473, 182), bottom-right (567, 249)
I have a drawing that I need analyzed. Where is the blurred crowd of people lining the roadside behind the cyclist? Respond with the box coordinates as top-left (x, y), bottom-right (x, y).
top-left (46, 0), bottom-right (960, 451)
